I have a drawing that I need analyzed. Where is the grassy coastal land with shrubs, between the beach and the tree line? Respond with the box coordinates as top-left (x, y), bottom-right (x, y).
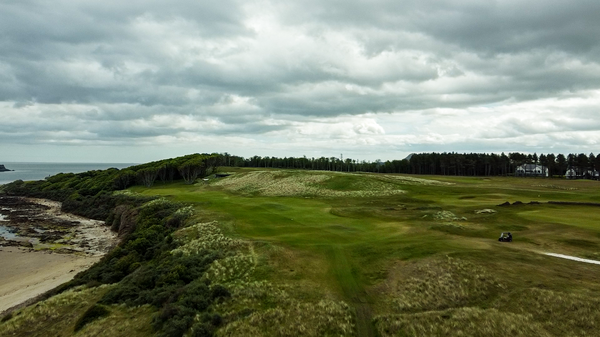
top-left (0, 164), bottom-right (600, 336)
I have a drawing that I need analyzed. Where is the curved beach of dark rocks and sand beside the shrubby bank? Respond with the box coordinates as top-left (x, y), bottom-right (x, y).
top-left (0, 196), bottom-right (117, 312)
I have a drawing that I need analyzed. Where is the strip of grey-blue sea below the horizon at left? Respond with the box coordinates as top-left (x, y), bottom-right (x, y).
top-left (0, 162), bottom-right (136, 185)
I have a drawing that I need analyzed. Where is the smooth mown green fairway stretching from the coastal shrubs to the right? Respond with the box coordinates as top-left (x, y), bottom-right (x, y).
top-left (129, 170), bottom-right (600, 336)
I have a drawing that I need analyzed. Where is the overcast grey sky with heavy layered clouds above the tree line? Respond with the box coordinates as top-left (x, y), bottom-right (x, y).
top-left (0, 0), bottom-right (600, 162)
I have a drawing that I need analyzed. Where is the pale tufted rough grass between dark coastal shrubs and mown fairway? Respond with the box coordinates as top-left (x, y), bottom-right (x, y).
top-left (173, 222), bottom-right (354, 336)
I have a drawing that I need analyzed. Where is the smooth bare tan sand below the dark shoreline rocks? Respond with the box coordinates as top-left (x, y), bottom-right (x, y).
top-left (0, 247), bottom-right (100, 313)
